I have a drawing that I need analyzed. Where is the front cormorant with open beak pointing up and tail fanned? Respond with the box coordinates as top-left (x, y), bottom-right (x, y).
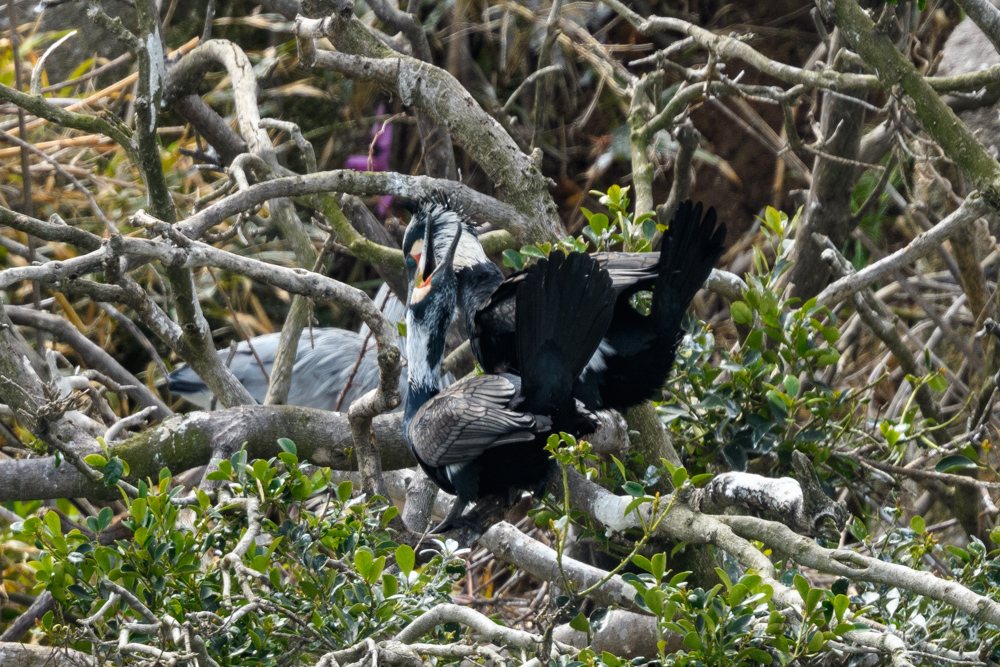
top-left (403, 219), bottom-right (615, 532)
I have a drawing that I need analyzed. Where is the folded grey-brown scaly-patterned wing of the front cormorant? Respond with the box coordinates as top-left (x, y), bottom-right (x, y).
top-left (410, 375), bottom-right (538, 466)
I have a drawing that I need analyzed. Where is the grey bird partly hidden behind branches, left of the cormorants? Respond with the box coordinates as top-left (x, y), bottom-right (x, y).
top-left (167, 284), bottom-right (407, 412)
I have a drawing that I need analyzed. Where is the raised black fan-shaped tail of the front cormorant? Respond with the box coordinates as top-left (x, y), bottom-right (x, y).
top-left (516, 252), bottom-right (615, 420)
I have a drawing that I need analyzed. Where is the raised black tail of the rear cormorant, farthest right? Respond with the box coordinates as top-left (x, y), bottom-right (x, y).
top-left (650, 200), bottom-right (726, 331)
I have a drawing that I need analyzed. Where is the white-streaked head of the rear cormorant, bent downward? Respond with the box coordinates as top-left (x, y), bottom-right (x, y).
top-left (403, 193), bottom-right (490, 284)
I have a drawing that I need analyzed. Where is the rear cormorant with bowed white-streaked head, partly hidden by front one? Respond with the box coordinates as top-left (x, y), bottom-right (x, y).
top-left (403, 198), bottom-right (726, 411)
